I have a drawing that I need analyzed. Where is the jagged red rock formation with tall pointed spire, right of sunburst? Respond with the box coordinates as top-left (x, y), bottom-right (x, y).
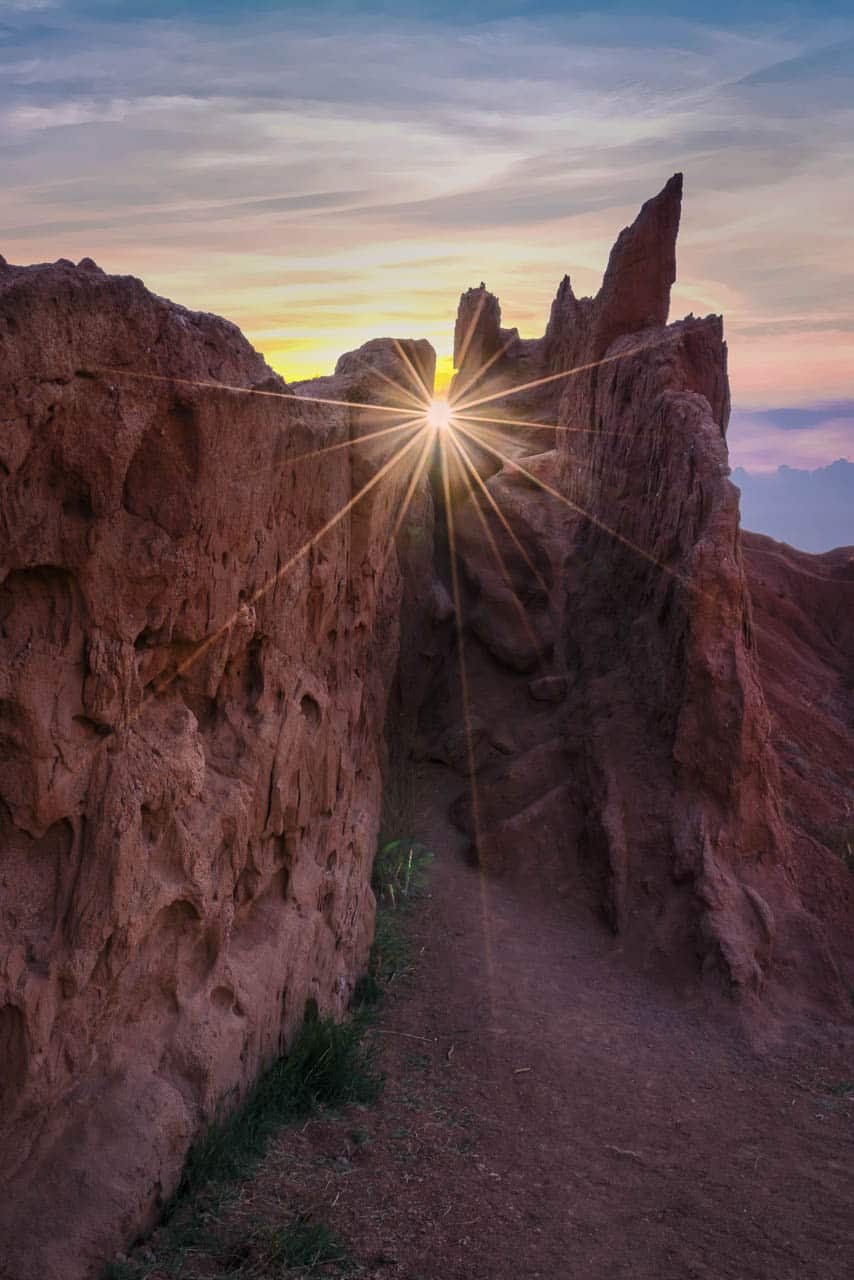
top-left (435, 174), bottom-right (851, 1014)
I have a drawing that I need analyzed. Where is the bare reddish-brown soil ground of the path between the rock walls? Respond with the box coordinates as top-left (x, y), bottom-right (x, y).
top-left (136, 769), bottom-right (854, 1280)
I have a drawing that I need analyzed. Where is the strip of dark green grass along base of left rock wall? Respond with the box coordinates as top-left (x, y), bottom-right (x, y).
top-left (101, 841), bottom-right (433, 1280)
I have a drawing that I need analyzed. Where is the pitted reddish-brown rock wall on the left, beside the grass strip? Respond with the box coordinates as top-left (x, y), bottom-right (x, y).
top-left (0, 261), bottom-right (433, 1280)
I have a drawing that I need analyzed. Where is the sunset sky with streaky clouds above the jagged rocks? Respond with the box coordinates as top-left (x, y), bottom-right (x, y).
top-left (0, 0), bottom-right (854, 472)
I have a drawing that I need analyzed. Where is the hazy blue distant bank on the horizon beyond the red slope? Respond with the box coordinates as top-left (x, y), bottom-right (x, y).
top-left (732, 458), bottom-right (854, 552)
